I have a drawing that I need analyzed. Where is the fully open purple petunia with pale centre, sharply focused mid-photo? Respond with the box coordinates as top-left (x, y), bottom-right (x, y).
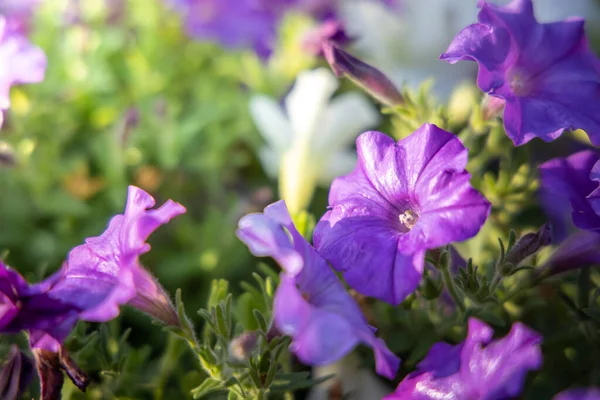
top-left (314, 124), bottom-right (490, 304)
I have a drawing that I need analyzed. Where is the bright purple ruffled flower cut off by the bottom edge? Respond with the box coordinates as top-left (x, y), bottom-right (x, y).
top-left (385, 318), bottom-right (542, 400)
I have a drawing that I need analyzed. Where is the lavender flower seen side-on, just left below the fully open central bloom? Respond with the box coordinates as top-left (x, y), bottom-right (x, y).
top-left (237, 201), bottom-right (400, 379)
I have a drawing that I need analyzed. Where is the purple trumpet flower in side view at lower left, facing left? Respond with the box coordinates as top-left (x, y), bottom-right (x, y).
top-left (0, 186), bottom-right (185, 352)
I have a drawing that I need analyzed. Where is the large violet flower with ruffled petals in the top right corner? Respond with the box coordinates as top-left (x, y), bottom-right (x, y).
top-left (440, 0), bottom-right (600, 146)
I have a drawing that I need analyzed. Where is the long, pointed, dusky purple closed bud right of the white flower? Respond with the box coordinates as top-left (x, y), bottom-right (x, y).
top-left (323, 41), bottom-right (404, 107)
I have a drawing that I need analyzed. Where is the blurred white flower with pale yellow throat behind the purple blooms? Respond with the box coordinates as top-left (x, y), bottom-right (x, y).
top-left (250, 68), bottom-right (379, 213)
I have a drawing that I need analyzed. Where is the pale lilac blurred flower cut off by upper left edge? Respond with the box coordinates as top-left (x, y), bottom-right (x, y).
top-left (0, 15), bottom-right (46, 112)
